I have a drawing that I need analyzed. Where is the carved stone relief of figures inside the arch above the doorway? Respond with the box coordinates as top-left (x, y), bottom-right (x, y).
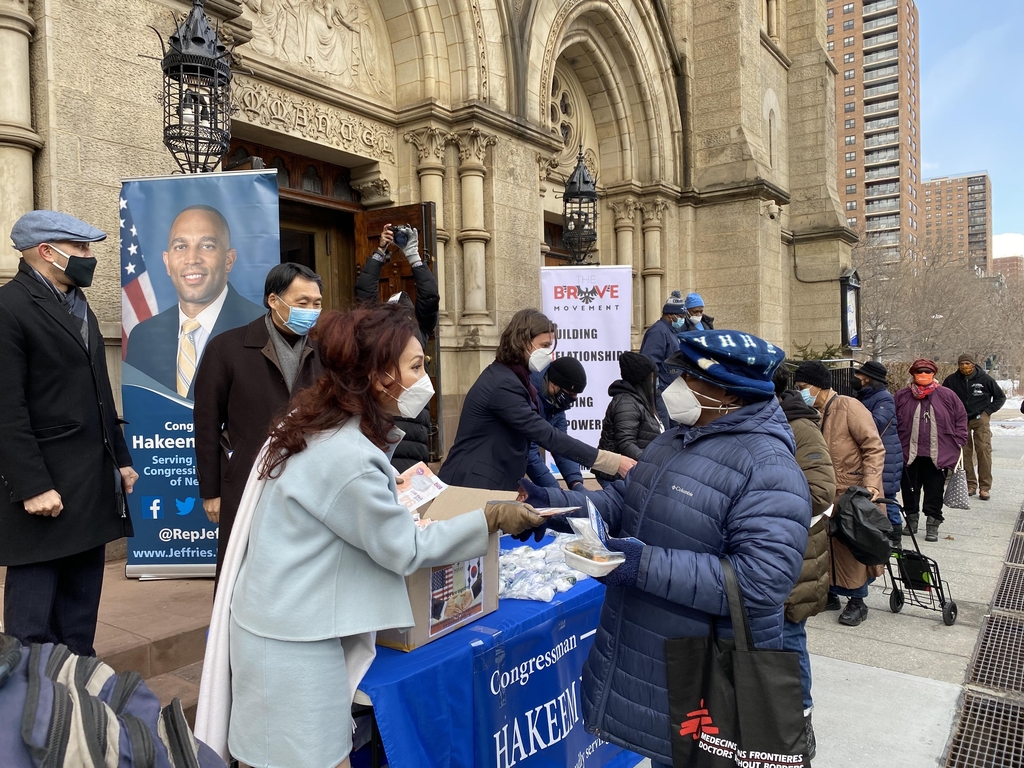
top-left (244, 0), bottom-right (394, 99)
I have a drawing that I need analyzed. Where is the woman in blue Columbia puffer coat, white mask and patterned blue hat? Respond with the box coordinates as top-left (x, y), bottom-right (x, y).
top-left (523, 331), bottom-right (811, 765)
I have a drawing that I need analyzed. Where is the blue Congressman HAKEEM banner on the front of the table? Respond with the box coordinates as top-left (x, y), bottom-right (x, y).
top-left (473, 600), bottom-right (643, 768)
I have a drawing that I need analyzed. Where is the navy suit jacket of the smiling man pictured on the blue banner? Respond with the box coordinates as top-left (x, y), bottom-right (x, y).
top-left (125, 283), bottom-right (266, 399)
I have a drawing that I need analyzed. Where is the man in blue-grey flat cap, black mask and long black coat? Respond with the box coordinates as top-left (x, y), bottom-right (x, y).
top-left (0, 211), bottom-right (138, 655)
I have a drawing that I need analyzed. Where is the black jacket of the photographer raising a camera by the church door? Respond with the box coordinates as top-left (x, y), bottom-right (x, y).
top-left (355, 259), bottom-right (440, 472)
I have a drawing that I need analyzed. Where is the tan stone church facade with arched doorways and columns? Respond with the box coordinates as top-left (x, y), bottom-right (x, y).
top-left (0, 0), bottom-right (855, 442)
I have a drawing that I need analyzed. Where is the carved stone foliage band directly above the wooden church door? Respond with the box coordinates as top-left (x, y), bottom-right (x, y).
top-left (232, 77), bottom-right (396, 164)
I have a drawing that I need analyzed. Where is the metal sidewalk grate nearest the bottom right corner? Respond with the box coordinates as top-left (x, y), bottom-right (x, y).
top-left (946, 693), bottom-right (1024, 768)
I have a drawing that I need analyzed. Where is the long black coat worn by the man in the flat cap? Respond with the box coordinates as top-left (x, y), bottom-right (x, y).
top-left (0, 261), bottom-right (133, 565)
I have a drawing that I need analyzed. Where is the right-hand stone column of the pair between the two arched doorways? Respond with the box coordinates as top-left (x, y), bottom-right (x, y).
top-left (455, 128), bottom-right (498, 323)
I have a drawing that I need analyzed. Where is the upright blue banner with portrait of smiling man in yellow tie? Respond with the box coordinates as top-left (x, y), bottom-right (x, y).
top-left (119, 171), bottom-right (281, 579)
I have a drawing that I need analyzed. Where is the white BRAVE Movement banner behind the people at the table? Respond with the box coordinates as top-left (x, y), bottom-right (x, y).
top-left (541, 266), bottom-right (633, 450)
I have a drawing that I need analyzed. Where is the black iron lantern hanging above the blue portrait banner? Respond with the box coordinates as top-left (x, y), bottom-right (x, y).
top-left (157, 0), bottom-right (231, 173)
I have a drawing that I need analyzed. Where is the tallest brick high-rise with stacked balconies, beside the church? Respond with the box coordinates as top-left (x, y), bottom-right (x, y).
top-left (826, 0), bottom-right (923, 259)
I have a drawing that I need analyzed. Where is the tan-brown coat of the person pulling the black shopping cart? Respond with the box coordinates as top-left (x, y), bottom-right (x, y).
top-left (821, 393), bottom-right (886, 589)
